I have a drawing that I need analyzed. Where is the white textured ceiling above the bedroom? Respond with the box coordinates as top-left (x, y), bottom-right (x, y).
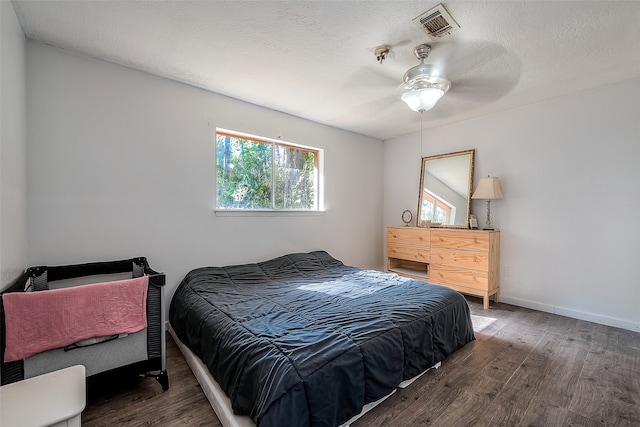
top-left (13, 0), bottom-right (640, 139)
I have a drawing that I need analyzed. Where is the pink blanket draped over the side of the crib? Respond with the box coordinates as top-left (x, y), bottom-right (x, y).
top-left (2, 276), bottom-right (149, 362)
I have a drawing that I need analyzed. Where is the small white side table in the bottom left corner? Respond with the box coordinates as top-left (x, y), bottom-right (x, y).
top-left (0, 365), bottom-right (86, 427)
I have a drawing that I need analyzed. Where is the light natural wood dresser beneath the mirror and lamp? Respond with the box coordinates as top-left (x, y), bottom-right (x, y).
top-left (387, 227), bottom-right (500, 308)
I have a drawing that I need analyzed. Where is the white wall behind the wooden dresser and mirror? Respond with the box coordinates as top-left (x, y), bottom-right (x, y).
top-left (384, 79), bottom-right (640, 330)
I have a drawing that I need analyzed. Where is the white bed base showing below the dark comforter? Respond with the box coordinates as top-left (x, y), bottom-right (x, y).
top-left (168, 324), bottom-right (442, 427)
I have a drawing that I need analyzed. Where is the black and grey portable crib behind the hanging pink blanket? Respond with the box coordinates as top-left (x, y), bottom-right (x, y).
top-left (0, 257), bottom-right (169, 390)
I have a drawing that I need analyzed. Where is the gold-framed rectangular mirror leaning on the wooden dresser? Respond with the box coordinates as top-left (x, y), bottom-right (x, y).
top-left (416, 150), bottom-right (476, 228)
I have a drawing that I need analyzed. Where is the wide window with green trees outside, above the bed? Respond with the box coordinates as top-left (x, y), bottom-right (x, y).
top-left (216, 129), bottom-right (321, 211)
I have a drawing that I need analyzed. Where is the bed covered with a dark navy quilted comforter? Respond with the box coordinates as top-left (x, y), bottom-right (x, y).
top-left (169, 251), bottom-right (474, 427)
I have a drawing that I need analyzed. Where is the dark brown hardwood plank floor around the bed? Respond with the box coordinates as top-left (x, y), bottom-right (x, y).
top-left (82, 297), bottom-right (640, 427)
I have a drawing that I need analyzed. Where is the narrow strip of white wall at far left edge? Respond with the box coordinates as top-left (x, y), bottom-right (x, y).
top-left (0, 1), bottom-right (27, 290)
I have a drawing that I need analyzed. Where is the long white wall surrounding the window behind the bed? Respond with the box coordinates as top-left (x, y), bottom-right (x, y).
top-left (27, 42), bottom-right (383, 306)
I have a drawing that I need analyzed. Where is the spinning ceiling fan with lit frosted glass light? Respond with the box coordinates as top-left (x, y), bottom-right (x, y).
top-left (345, 37), bottom-right (522, 118)
